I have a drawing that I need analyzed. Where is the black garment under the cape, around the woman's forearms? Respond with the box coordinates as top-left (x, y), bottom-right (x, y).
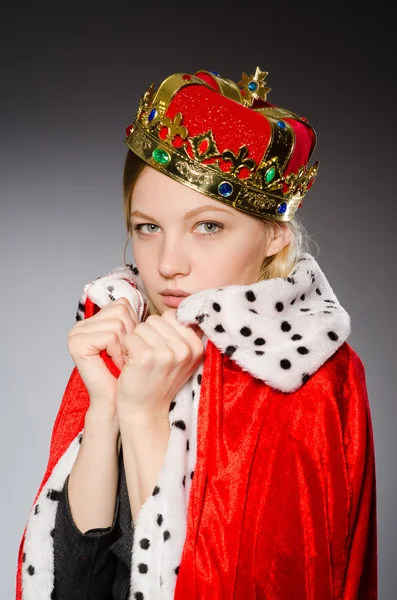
top-left (52, 448), bottom-right (133, 600)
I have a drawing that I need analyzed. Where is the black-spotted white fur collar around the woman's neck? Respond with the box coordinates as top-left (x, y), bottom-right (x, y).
top-left (77, 253), bottom-right (351, 392)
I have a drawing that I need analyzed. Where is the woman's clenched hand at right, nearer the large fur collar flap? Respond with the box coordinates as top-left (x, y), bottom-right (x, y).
top-left (115, 309), bottom-right (204, 423)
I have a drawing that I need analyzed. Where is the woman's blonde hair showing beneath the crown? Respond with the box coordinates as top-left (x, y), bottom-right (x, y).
top-left (123, 150), bottom-right (315, 320)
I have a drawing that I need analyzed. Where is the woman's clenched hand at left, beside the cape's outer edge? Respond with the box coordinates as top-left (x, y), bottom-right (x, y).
top-left (68, 297), bottom-right (138, 410)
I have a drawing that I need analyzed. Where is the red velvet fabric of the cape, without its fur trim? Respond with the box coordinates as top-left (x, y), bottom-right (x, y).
top-left (16, 299), bottom-right (377, 600)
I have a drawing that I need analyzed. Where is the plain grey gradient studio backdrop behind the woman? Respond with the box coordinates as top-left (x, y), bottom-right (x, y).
top-left (0, 0), bottom-right (397, 600)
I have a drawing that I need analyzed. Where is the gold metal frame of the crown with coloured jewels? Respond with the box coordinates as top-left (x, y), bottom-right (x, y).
top-left (124, 67), bottom-right (319, 221)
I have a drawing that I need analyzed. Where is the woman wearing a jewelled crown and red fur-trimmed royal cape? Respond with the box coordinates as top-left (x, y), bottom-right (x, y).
top-left (17, 68), bottom-right (377, 600)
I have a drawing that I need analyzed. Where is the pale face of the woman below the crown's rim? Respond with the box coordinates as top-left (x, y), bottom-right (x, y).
top-left (131, 167), bottom-right (286, 314)
